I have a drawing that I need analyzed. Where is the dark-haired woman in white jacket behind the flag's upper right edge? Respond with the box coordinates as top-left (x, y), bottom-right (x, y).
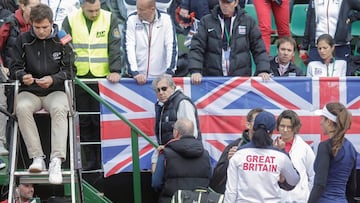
top-left (306, 34), bottom-right (347, 77)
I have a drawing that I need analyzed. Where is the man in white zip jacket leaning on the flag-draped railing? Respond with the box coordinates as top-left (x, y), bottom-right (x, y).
top-left (125, 0), bottom-right (178, 85)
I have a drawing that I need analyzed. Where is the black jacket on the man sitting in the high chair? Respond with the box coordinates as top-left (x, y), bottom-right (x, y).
top-left (10, 24), bottom-right (76, 96)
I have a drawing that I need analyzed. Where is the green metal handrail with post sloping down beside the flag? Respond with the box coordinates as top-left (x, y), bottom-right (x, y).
top-left (75, 77), bottom-right (158, 203)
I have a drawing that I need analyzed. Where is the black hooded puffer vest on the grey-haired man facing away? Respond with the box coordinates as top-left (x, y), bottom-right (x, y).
top-left (159, 136), bottom-right (211, 202)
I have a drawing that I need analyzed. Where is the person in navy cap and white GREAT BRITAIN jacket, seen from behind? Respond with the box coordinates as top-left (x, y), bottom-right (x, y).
top-left (224, 111), bottom-right (300, 203)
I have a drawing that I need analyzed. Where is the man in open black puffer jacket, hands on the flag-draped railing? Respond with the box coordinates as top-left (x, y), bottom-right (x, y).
top-left (189, 0), bottom-right (270, 84)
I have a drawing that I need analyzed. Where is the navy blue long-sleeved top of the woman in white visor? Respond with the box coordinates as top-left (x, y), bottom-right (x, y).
top-left (308, 139), bottom-right (357, 203)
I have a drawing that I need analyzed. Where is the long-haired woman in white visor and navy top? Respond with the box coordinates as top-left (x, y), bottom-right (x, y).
top-left (308, 102), bottom-right (357, 203)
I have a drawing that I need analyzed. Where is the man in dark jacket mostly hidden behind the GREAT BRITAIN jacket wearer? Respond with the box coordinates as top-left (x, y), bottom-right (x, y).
top-left (210, 108), bottom-right (264, 194)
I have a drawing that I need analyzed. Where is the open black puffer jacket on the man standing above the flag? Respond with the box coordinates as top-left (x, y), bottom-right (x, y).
top-left (189, 6), bottom-right (270, 76)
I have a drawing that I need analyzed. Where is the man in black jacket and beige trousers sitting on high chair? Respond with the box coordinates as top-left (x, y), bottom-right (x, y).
top-left (11, 4), bottom-right (75, 184)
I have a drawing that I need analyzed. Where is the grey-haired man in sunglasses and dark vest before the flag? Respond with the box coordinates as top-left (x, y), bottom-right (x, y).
top-left (152, 74), bottom-right (201, 171)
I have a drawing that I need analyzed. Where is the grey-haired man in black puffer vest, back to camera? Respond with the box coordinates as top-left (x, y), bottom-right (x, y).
top-left (152, 118), bottom-right (211, 203)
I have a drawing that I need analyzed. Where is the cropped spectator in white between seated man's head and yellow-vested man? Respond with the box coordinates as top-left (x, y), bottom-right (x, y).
top-left (41, 0), bottom-right (80, 30)
